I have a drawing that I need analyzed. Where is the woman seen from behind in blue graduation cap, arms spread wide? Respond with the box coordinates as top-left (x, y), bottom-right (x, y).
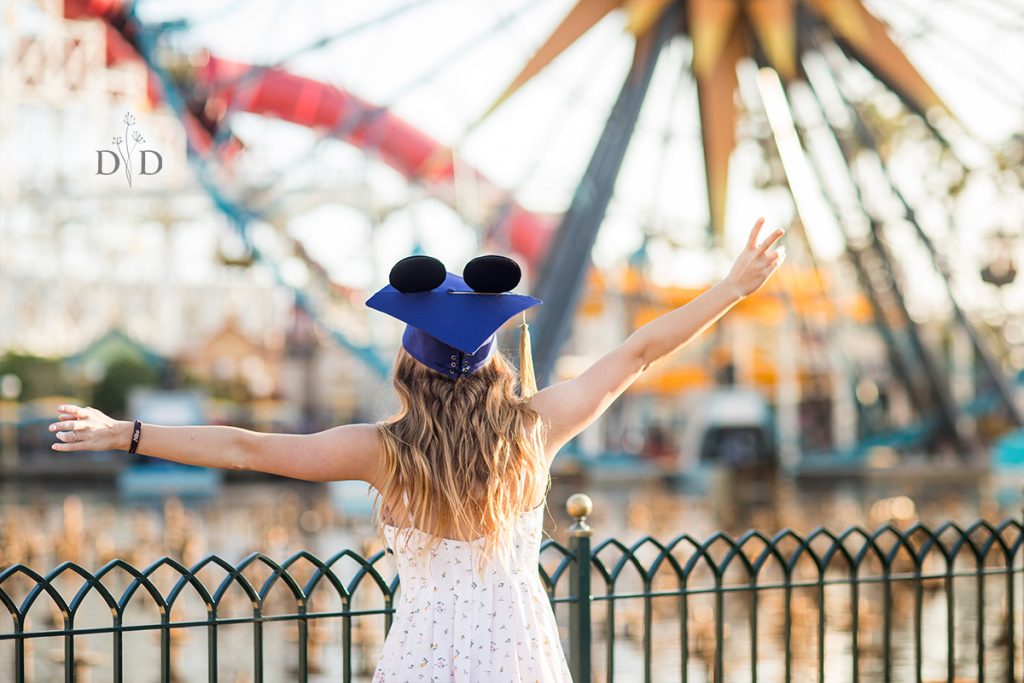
top-left (50, 219), bottom-right (784, 682)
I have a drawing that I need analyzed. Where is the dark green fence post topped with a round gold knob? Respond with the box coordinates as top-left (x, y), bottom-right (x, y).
top-left (565, 494), bottom-right (593, 683)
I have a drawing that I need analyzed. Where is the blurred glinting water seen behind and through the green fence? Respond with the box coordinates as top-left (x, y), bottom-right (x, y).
top-left (0, 477), bottom-right (1024, 683)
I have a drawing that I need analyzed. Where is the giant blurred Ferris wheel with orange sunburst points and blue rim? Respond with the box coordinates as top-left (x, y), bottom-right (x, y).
top-left (66, 0), bottom-right (1024, 451)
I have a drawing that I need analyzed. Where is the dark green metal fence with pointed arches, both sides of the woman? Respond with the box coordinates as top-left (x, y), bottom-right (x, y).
top-left (0, 495), bottom-right (1024, 683)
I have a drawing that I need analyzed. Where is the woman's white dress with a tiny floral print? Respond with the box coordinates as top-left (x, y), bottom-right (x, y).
top-left (373, 504), bottom-right (572, 683)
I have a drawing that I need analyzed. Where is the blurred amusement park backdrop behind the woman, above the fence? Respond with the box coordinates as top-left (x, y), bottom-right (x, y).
top-left (0, 0), bottom-right (1024, 679)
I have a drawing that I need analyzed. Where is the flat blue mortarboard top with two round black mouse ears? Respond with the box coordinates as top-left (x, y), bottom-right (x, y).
top-left (367, 255), bottom-right (542, 356)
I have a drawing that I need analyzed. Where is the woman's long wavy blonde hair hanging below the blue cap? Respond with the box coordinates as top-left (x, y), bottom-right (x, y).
top-left (375, 347), bottom-right (549, 574)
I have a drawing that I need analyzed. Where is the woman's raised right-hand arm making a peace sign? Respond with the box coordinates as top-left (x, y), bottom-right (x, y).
top-left (530, 218), bottom-right (785, 463)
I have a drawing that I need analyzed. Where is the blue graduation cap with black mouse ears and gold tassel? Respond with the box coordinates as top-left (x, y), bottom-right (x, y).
top-left (367, 254), bottom-right (542, 396)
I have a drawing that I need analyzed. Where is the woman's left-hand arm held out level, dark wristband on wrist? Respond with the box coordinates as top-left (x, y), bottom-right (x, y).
top-left (50, 403), bottom-right (380, 483)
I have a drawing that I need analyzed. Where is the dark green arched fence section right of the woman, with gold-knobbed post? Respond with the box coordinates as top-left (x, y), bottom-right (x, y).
top-left (566, 497), bottom-right (1024, 683)
